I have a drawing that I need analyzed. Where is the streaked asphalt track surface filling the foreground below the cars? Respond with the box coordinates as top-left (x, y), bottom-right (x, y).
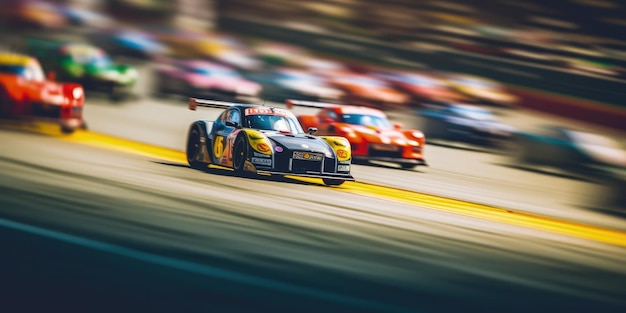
top-left (0, 117), bottom-right (626, 312)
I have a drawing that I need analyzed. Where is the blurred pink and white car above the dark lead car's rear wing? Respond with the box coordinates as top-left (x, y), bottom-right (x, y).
top-left (155, 58), bottom-right (263, 101)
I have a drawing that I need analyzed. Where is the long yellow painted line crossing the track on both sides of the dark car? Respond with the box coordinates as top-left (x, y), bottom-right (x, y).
top-left (6, 125), bottom-right (626, 247)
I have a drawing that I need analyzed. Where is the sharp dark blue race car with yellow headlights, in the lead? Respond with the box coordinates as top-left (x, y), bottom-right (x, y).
top-left (186, 98), bottom-right (354, 186)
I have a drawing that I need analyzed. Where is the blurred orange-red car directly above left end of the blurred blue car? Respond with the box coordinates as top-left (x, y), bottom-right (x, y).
top-left (374, 71), bottom-right (465, 106)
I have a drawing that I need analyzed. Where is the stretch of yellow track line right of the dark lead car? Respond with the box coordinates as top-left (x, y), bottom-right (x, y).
top-left (342, 183), bottom-right (626, 246)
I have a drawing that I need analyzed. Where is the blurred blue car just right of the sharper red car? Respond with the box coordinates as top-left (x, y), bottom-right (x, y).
top-left (419, 103), bottom-right (516, 146)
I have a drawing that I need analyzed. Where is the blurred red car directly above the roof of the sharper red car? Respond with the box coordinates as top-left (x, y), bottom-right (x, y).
top-left (328, 73), bottom-right (409, 109)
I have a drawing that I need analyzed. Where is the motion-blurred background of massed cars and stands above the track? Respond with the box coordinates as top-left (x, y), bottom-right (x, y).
top-left (0, 0), bottom-right (626, 205)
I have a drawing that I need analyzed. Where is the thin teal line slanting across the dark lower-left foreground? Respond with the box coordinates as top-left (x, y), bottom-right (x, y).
top-left (0, 218), bottom-right (413, 312)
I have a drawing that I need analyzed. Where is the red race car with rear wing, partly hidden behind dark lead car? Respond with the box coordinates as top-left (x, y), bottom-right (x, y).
top-left (286, 99), bottom-right (427, 169)
